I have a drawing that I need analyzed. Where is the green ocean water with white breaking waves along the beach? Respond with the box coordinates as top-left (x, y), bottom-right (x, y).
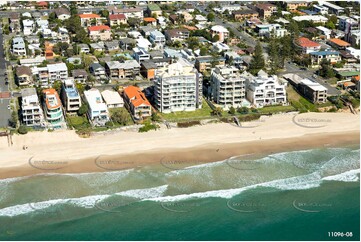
top-left (0, 146), bottom-right (360, 241)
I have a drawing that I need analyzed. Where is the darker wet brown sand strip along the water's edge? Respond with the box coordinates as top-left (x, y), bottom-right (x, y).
top-left (0, 132), bottom-right (360, 179)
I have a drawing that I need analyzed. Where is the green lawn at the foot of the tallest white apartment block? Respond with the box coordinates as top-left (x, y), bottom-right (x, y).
top-left (160, 100), bottom-right (212, 121)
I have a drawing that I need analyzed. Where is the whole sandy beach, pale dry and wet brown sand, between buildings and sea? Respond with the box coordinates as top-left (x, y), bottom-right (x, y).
top-left (0, 113), bottom-right (360, 178)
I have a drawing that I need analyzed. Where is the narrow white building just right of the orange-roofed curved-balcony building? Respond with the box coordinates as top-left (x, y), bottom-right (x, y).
top-left (61, 79), bottom-right (81, 112)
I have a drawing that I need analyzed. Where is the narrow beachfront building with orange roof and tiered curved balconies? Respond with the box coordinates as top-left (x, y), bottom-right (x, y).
top-left (43, 88), bottom-right (66, 129)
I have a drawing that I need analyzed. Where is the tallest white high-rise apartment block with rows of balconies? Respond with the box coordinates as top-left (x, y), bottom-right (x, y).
top-left (154, 58), bottom-right (202, 113)
